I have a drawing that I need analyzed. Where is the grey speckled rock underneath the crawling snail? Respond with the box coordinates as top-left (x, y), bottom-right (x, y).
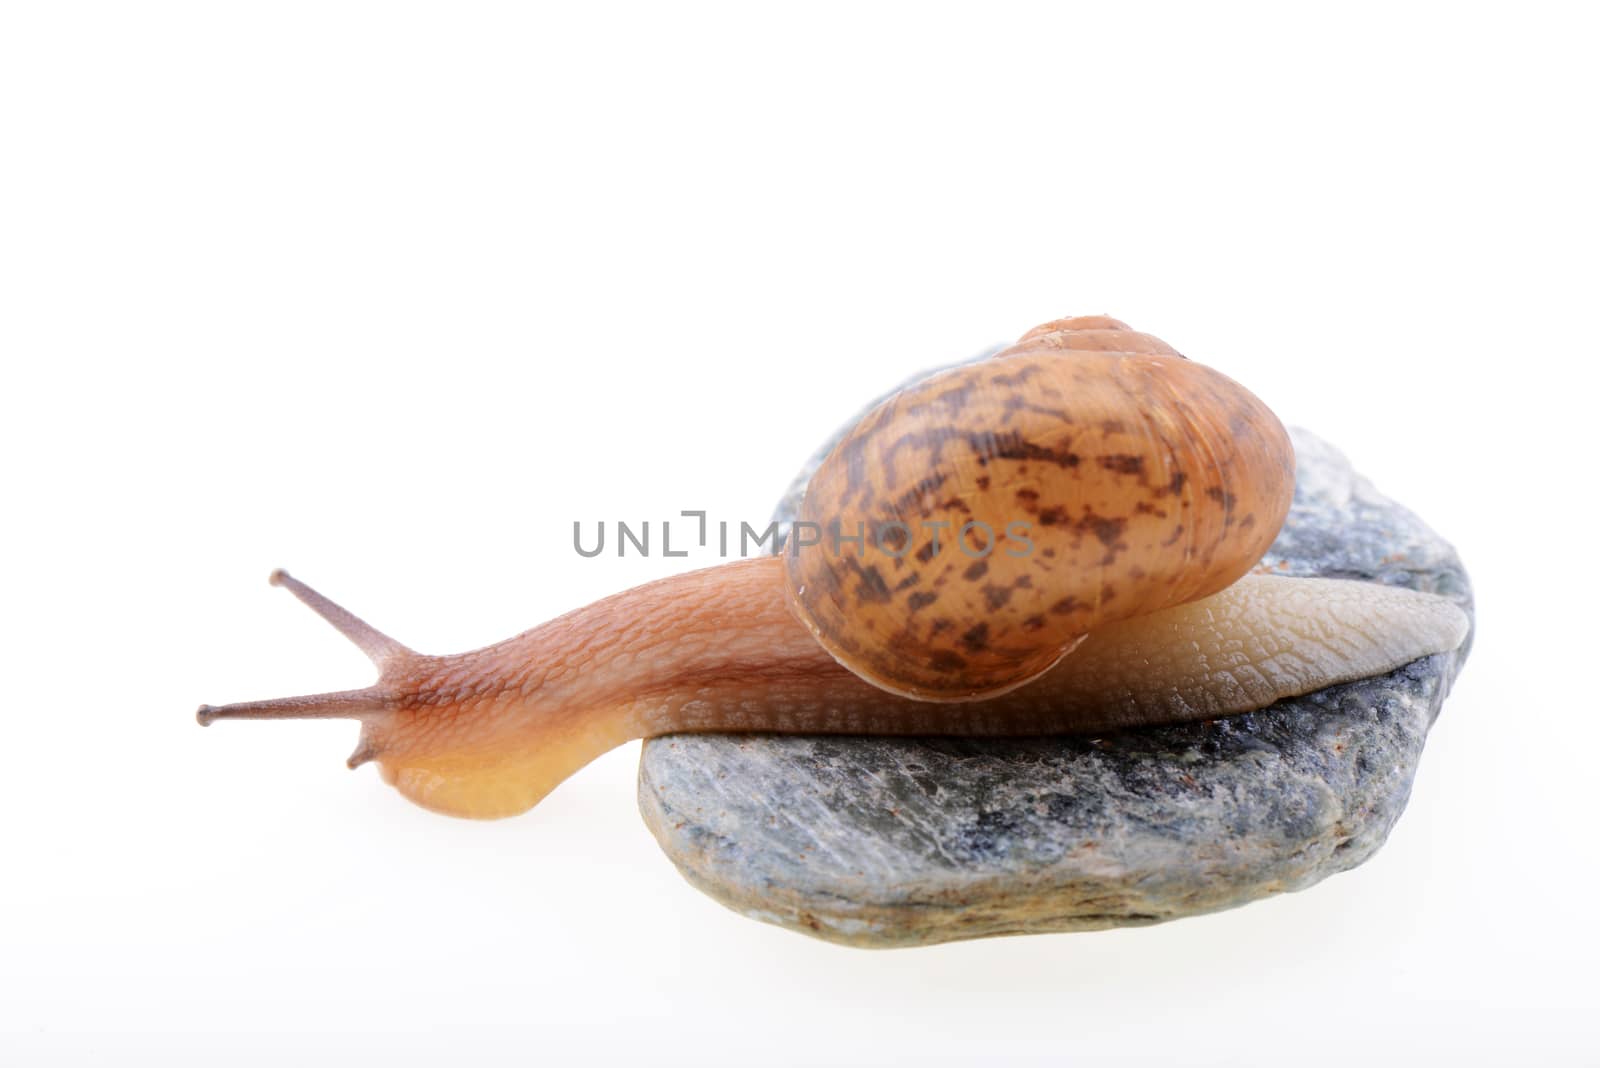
top-left (638, 362), bottom-right (1472, 946)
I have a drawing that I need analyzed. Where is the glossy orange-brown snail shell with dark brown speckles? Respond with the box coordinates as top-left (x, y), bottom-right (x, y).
top-left (786, 317), bottom-right (1294, 700)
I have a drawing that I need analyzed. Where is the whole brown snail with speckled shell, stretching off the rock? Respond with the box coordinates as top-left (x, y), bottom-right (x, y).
top-left (198, 317), bottom-right (1467, 819)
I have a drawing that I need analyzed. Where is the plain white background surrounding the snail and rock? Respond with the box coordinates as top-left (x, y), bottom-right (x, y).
top-left (0, 2), bottom-right (1600, 1065)
